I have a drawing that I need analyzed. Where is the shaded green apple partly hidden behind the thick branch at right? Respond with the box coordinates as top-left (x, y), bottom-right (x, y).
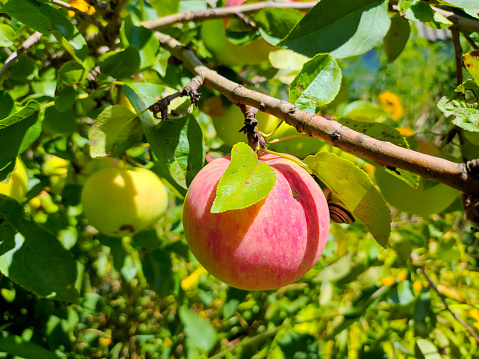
top-left (374, 138), bottom-right (459, 217)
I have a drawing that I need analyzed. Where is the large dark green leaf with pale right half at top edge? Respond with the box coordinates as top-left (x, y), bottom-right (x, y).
top-left (278, 0), bottom-right (391, 59)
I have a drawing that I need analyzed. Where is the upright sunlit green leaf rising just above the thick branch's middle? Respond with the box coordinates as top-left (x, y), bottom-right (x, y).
top-left (289, 54), bottom-right (341, 113)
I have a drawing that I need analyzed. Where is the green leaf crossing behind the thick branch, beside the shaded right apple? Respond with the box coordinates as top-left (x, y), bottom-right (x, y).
top-left (334, 118), bottom-right (419, 188)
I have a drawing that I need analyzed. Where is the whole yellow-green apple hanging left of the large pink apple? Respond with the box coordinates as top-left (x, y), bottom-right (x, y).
top-left (82, 168), bottom-right (168, 237)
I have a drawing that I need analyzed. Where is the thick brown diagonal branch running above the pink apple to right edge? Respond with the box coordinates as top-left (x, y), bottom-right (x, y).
top-left (156, 32), bottom-right (479, 196)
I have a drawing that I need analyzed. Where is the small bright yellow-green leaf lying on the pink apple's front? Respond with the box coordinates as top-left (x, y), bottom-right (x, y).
top-left (211, 142), bottom-right (276, 213)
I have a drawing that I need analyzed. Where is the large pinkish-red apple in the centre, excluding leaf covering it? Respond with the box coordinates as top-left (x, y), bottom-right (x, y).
top-left (183, 154), bottom-right (329, 290)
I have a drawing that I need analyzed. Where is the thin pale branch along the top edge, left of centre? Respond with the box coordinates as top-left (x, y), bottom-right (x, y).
top-left (142, 1), bottom-right (316, 30)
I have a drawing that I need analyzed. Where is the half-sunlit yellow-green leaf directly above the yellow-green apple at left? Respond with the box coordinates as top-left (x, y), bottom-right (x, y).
top-left (88, 105), bottom-right (143, 158)
